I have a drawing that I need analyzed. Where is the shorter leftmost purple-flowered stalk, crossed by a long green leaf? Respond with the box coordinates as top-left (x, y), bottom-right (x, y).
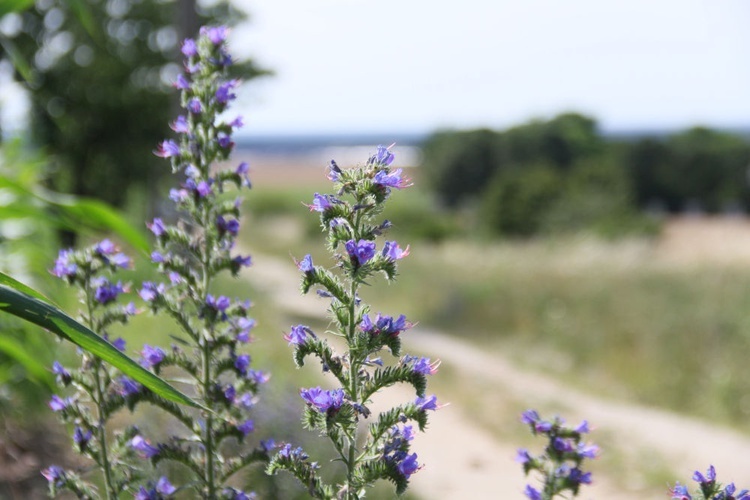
top-left (43, 239), bottom-right (146, 498)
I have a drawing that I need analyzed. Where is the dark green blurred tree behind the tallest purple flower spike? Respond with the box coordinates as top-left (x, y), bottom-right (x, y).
top-left (0, 0), bottom-right (263, 218)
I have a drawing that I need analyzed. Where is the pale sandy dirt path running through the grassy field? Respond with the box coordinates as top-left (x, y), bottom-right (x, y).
top-left (252, 255), bottom-right (750, 500)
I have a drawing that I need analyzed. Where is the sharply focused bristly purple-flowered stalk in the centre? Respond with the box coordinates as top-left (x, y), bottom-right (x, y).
top-left (268, 146), bottom-right (438, 499)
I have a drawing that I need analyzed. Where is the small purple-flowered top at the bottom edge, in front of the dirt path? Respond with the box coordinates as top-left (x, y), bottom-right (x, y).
top-left (516, 410), bottom-right (599, 500)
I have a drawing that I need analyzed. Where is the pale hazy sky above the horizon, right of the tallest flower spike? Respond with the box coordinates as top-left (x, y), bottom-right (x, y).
top-left (231, 0), bottom-right (750, 134)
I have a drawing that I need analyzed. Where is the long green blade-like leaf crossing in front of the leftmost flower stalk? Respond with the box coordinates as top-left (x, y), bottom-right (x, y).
top-left (0, 282), bottom-right (206, 410)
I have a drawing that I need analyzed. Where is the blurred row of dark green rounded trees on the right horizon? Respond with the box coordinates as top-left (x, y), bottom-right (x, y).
top-left (423, 113), bottom-right (750, 236)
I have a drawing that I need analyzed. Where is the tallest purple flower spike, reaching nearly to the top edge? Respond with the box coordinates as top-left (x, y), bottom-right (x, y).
top-left (130, 27), bottom-right (268, 498)
